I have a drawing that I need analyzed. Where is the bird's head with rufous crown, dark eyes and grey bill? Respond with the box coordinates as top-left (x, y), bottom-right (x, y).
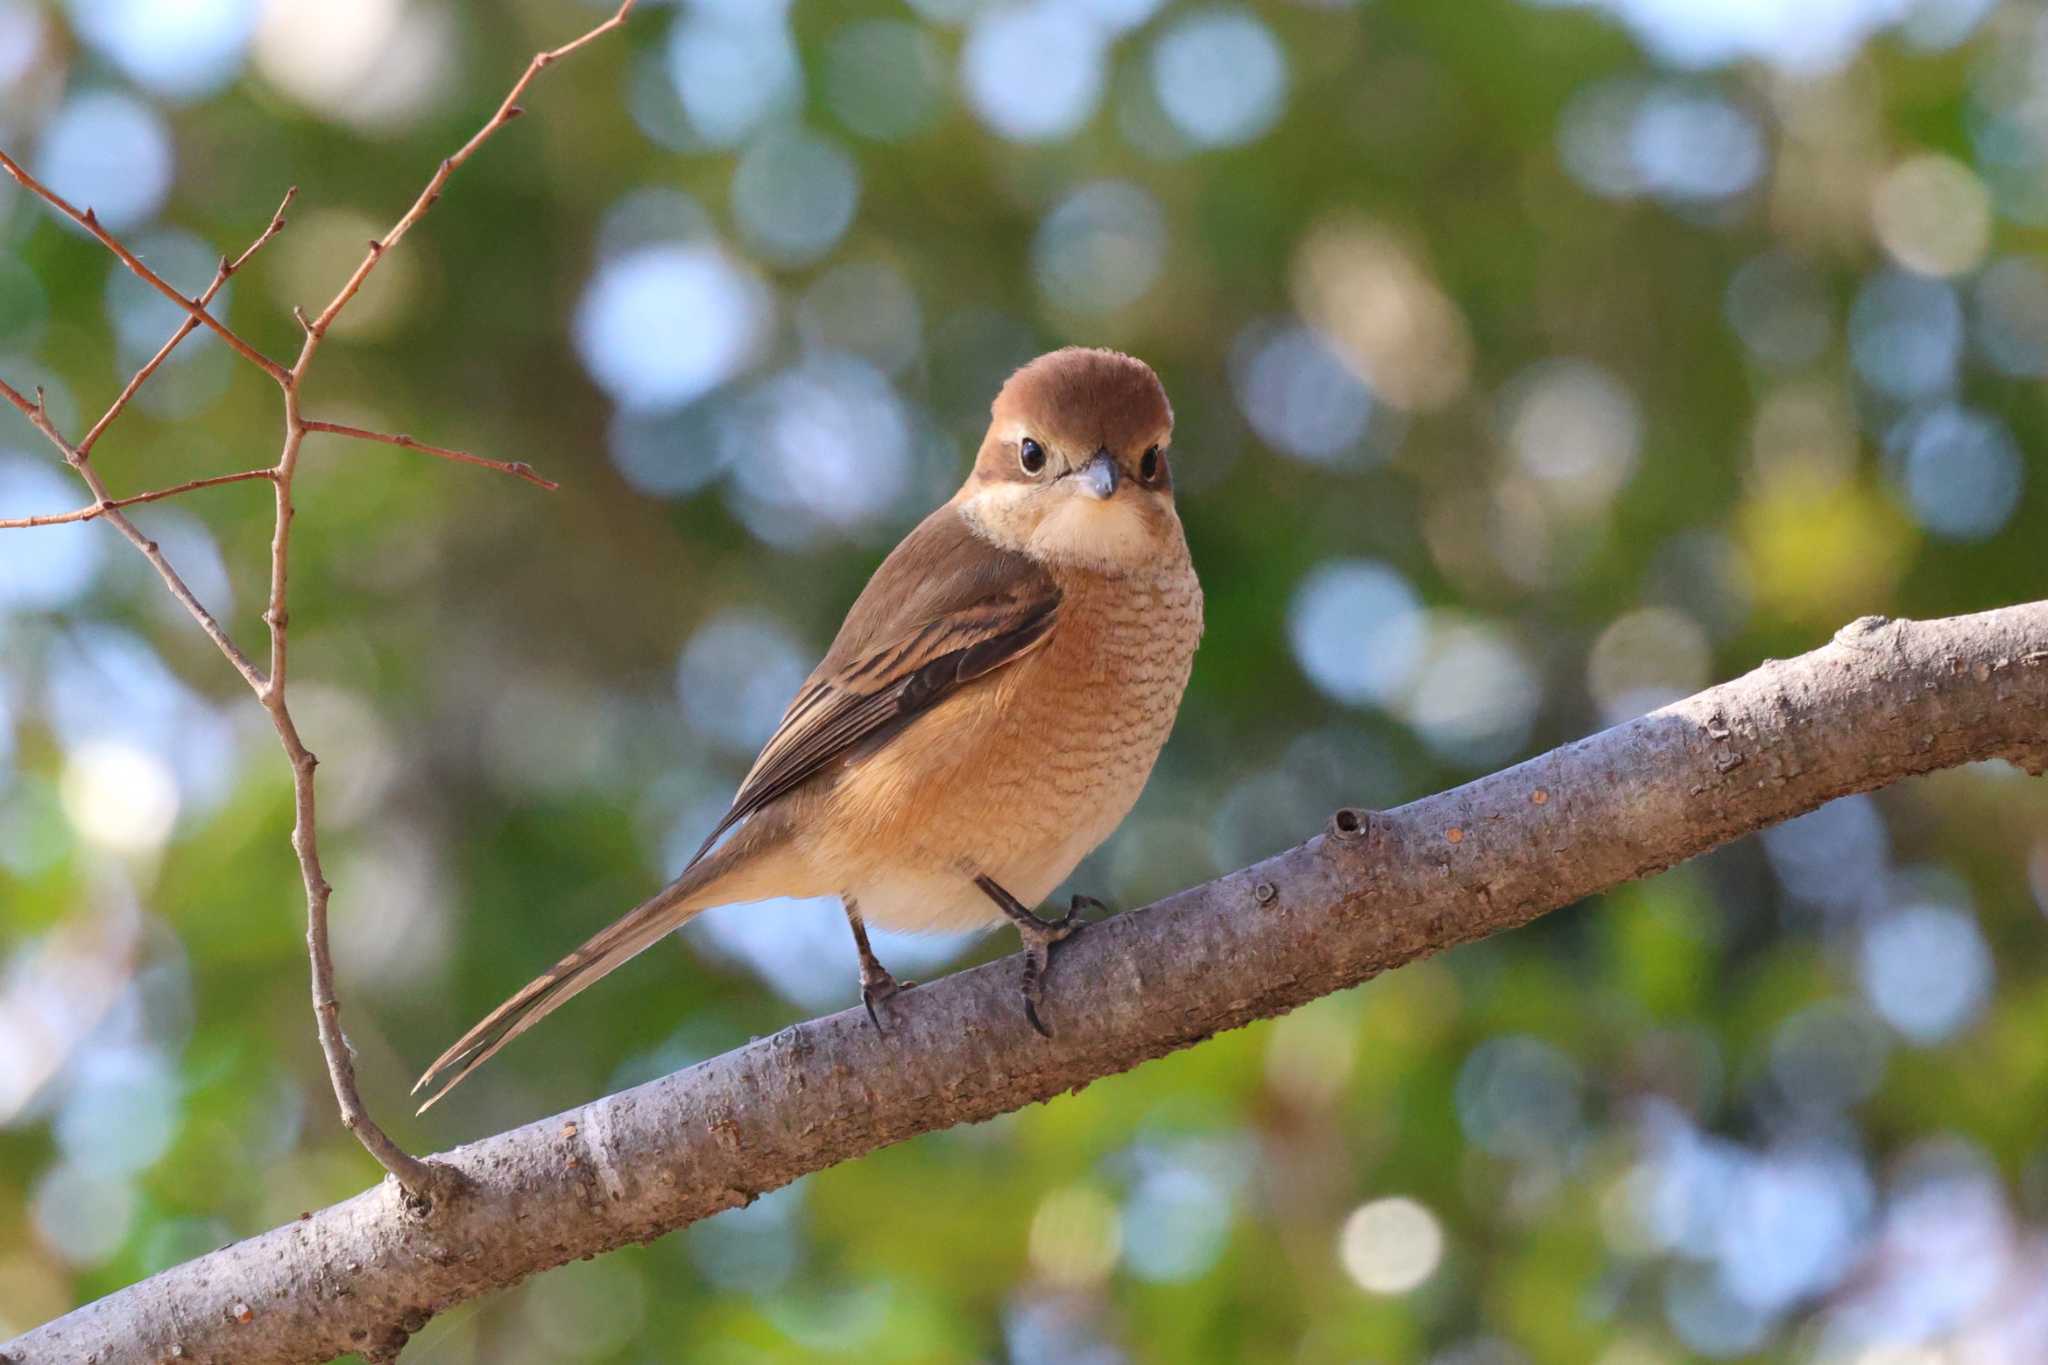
top-left (954, 346), bottom-right (1182, 573)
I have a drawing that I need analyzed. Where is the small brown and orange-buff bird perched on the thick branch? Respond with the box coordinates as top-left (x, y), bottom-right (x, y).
top-left (414, 346), bottom-right (1202, 1113)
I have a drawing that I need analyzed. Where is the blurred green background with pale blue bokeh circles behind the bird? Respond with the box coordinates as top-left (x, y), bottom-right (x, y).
top-left (0, 0), bottom-right (2048, 1365)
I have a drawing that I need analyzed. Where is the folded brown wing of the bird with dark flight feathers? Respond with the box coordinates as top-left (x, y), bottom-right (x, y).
top-left (692, 505), bottom-right (1061, 862)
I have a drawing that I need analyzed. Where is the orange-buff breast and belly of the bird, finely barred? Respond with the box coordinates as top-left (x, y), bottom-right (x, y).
top-left (805, 561), bottom-right (1202, 929)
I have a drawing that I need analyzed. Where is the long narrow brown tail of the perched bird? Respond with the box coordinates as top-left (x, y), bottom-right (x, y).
top-left (412, 829), bottom-right (762, 1113)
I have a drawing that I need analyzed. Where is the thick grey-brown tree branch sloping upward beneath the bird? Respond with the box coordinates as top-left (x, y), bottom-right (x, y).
top-left (4, 602), bottom-right (2048, 1365)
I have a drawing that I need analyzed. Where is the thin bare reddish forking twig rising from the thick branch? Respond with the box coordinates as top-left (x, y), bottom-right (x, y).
top-left (0, 0), bottom-right (635, 1203)
